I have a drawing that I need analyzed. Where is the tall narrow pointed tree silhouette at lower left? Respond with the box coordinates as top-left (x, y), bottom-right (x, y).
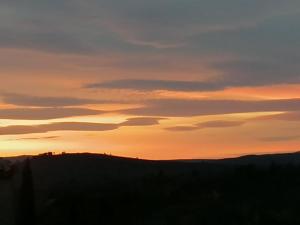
top-left (16, 159), bottom-right (35, 225)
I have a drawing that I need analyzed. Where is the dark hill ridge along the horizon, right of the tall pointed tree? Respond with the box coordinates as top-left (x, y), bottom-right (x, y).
top-left (25, 152), bottom-right (300, 197)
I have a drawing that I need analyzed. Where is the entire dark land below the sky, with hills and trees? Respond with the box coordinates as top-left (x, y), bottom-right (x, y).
top-left (0, 153), bottom-right (300, 225)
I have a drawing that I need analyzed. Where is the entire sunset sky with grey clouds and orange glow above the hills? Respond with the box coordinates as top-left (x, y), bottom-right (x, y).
top-left (0, 0), bottom-right (300, 159)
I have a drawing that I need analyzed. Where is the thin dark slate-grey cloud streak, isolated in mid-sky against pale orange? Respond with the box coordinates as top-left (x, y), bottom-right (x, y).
top-left (86, 79), bottom-right (223, 91)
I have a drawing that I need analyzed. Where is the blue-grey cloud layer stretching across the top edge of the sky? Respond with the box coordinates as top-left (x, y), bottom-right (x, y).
top-left (0, 0), bottom-right (299, 52)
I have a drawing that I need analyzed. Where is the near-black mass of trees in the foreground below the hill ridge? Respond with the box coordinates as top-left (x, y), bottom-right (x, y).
top-left (37, 164), bottom-right (300, 225)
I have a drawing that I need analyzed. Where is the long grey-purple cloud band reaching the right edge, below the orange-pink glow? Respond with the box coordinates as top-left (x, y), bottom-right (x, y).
top-left (120, 99), bottom-right (300, 117)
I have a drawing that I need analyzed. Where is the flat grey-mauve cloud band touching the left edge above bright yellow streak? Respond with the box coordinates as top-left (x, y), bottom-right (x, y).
top-left (0, 108), bottom-right (105, 120)
